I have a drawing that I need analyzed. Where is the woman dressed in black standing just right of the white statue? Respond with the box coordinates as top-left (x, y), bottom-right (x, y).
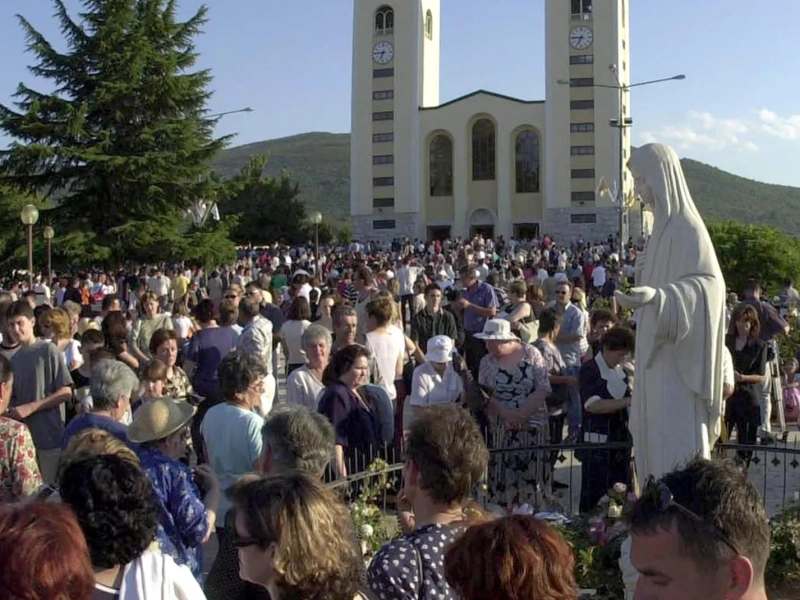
top-left (725, 304), bottom-right (767, 466)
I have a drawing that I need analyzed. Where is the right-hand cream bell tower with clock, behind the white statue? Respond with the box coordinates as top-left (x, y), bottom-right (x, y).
top-left (545, 0), bottom-right (633, 239)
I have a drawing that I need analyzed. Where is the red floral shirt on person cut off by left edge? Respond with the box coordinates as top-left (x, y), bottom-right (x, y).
top-left (0, 417), bottom-right (42, 504)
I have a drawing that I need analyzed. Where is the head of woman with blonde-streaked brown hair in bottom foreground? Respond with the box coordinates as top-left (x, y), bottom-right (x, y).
top-left (227, 472), bottom-right (364, 600)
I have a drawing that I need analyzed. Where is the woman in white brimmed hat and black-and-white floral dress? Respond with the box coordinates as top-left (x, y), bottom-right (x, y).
top-left (475, 319), bottom-right (551, 509)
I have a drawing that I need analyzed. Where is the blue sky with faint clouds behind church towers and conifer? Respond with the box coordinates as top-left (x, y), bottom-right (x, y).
top-left (0, 0), bottom-right (800, 186)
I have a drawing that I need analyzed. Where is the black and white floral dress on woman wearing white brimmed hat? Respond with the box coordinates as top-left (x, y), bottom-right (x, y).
top-left (478, 344), bottom-right (550, 507)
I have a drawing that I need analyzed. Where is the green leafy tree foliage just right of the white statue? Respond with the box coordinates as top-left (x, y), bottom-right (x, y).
top-left (708, 221), bottom-right (800, 295)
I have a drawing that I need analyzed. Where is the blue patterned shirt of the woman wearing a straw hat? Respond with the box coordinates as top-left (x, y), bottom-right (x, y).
top-left (139, 447), bottom-right (208, 584)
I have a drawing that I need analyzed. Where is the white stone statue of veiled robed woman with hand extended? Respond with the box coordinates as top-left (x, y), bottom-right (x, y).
top-left (617, 144), bottom-right (725, 481)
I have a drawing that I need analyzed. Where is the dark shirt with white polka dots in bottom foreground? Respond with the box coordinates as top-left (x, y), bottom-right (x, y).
top-left (367, 523), bottom-right (464, 600)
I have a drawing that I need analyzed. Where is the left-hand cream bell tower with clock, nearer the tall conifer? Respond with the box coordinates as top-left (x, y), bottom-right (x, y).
top-left (350, 0), bottom-right (440, 240)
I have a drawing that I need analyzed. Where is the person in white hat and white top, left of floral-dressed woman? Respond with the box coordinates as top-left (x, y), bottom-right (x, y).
top-left (410, 335), bottom-right (464, 429)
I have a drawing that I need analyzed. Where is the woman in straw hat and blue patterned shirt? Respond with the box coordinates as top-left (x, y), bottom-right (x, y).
top-left (128, 398), bottom-right (220, 584)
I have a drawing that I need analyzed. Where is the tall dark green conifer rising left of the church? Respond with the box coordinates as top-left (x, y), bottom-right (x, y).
top-left (0, 0), bottom-right (229, 260)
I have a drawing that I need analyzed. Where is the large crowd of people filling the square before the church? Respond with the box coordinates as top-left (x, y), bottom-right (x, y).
top-left (0, 236), bottom-right (780, 600)
